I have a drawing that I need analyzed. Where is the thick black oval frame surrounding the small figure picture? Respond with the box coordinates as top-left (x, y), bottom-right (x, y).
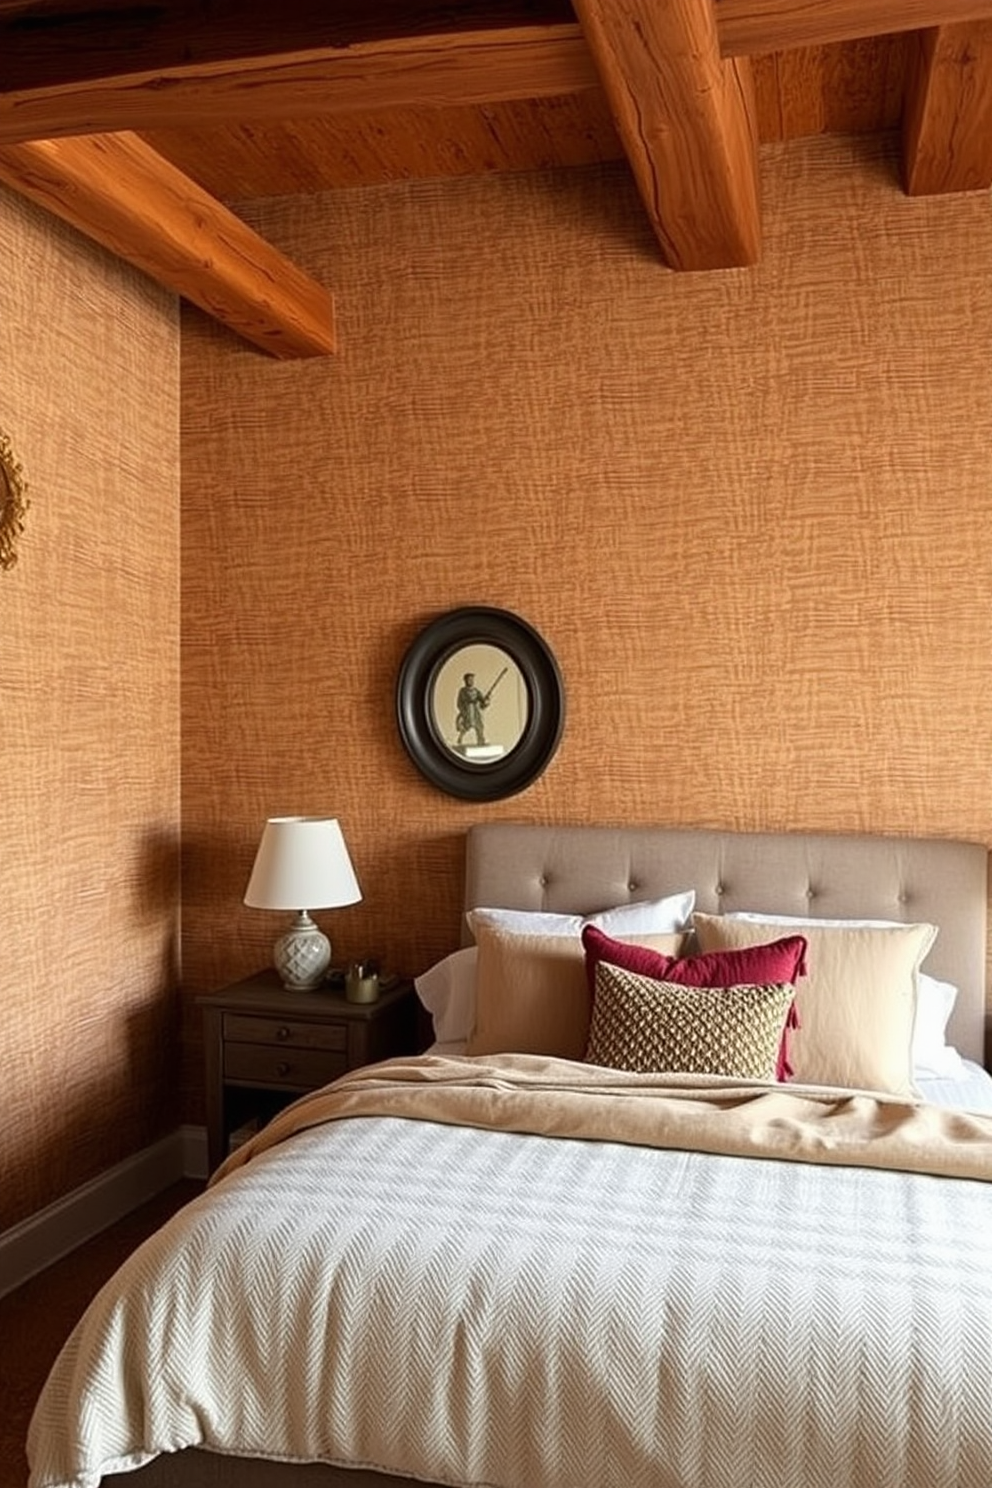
top-left (396, 606), bottom-right (565, 801)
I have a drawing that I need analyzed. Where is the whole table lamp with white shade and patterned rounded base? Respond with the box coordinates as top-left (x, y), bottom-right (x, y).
top-left (244, 817), bottom-right (361, 991)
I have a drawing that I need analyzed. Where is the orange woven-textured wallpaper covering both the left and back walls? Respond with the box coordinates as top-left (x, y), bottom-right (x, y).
top-left (0, 133), bottom-right (992, 1229)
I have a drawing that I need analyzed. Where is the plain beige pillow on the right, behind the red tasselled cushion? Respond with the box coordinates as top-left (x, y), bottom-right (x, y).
top-left (693, 914), bottom-right (937, 1097)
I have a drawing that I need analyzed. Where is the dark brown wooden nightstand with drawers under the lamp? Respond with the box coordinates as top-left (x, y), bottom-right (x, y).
top-left (196, 970), bottom-right (418, 1173)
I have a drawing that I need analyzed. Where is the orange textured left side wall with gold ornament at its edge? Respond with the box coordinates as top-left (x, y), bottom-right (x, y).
top-left (0, 190), bottom-right (180, 1231)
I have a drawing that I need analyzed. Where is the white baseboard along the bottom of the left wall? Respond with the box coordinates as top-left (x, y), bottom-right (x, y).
top-left (0, 1126), bottom-right (208, 1296)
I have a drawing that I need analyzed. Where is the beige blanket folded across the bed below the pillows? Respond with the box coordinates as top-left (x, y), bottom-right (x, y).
top-left (213, 1055), bottom-right (992, 1181)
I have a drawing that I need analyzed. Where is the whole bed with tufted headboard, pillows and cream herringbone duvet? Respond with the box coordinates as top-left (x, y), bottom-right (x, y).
top-left (28, 824), bottom-right (992, 1488)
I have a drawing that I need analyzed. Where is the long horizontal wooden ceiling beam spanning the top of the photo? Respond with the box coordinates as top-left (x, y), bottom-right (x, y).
top-left (0, 0), bottom-right (992, 141)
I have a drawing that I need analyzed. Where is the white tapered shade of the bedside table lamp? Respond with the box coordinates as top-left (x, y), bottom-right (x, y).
top-left (244, 817), bottom-right (361, 909)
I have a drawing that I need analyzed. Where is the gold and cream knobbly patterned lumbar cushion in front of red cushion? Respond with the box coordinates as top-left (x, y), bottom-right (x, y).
top-left (586, 961), bottom-right (796, 1080)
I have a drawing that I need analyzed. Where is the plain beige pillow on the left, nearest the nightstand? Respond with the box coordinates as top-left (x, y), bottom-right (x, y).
top-left (466, 924), bottom-right (686, 1059)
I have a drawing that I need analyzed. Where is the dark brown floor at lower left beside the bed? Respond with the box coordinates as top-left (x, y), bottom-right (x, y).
top-left (0, 1180), bottom-right (202, 1488)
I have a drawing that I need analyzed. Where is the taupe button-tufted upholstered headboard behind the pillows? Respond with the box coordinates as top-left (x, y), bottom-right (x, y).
top-left (464, 823), bottom-right (988, 1062)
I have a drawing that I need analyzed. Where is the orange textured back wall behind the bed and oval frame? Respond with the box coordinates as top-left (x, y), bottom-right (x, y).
top-left (181, 140), bottom-right (992, 1116)
